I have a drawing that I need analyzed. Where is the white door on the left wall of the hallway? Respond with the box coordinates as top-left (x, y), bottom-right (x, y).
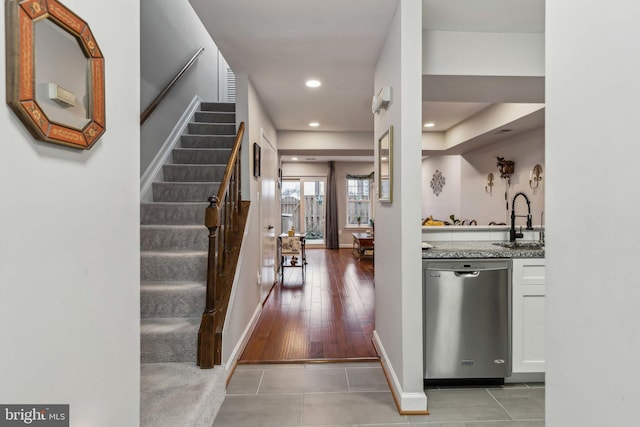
top-left (260, 132), bottom-right (278, 302)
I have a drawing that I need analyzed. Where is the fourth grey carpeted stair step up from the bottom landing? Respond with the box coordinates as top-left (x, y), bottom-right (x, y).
top-left (140, 225), bottom-right (209, 251)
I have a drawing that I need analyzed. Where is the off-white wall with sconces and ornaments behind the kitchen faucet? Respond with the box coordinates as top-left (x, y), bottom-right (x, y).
top-left (422, 128), bottom-right (547, 225)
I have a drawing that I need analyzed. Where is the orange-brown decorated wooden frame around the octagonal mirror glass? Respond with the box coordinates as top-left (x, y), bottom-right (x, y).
top-left (5, 0), bottom-right (106, 149)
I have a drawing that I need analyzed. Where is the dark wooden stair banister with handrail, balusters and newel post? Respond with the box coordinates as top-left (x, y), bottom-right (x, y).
top-left (197, 122), bottom-right (245, 369)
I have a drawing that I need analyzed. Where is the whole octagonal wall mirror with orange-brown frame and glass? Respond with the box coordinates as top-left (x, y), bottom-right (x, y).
top-left (5, 0), bottom-right (106, 149)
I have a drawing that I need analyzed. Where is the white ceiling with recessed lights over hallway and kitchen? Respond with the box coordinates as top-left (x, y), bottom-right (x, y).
top-left (190, 0), bottom-right (544, 144)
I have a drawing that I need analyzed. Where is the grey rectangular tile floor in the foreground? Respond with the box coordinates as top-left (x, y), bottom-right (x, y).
top-left (213, 362), bottom-right (545, 427)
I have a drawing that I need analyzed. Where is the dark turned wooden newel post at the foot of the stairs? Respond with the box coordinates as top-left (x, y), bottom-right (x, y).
top-left (197, 196), bottom-right (220, 369)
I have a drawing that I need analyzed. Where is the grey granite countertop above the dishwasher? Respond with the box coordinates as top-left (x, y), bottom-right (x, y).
top-left (422, 241), bottom-right (544, 259)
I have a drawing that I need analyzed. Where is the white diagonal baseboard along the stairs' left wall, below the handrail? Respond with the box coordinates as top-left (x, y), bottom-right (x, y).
top-left (140, 95), bottom-right (202, 202)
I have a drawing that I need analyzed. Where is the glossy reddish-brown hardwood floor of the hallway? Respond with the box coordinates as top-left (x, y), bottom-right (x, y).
top-left (239, 249), bottom-right (377, 363)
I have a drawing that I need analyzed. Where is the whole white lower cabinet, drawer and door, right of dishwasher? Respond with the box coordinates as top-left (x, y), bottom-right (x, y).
top-left (512, 258), bottom-right (545, 373)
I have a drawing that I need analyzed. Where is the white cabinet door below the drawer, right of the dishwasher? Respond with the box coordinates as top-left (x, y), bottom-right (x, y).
top-left (512, 285), bottom-right (545, 373)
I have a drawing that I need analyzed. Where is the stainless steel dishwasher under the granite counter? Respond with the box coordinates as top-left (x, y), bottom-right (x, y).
top-left (422, 259), bottom-right (511, 383)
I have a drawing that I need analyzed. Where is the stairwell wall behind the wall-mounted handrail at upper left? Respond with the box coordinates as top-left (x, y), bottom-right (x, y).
top-left (141, 0), bottom-right (219, 176)
